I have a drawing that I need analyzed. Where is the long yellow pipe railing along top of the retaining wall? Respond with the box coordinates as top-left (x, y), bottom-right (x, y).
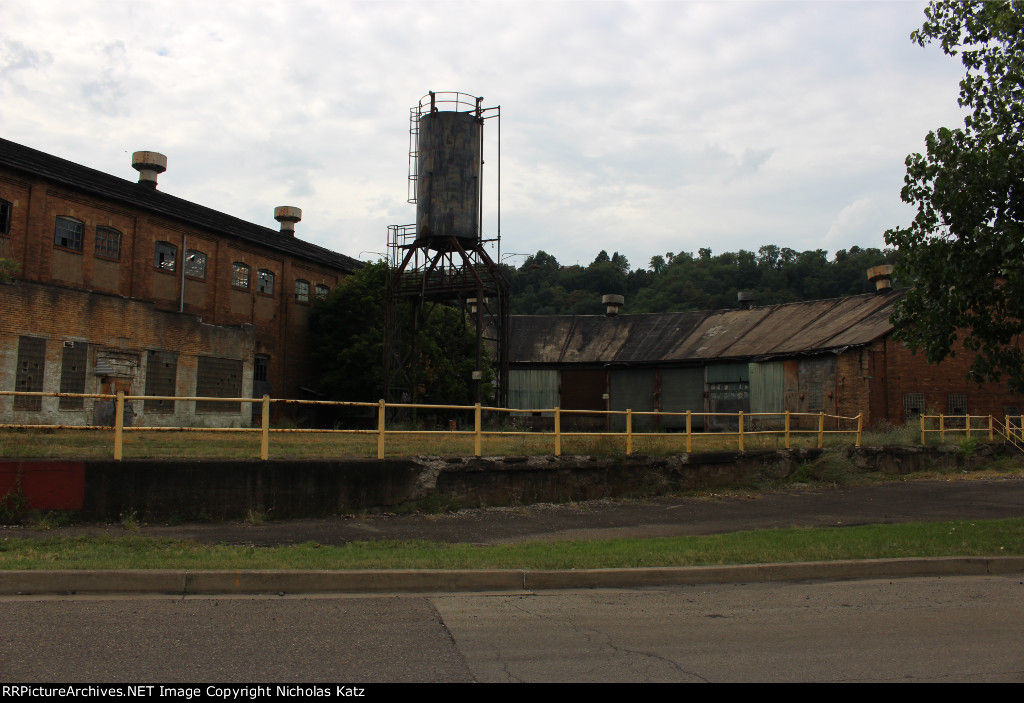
top-left (0, 391), bottom-right (863, 460)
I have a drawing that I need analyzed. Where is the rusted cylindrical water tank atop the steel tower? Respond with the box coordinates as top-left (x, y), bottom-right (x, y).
top-left (416, 105), bottom-right (483, 249)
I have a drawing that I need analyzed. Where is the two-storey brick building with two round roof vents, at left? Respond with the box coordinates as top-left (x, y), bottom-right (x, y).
top-left (0, 139), bottom-right (361, 426)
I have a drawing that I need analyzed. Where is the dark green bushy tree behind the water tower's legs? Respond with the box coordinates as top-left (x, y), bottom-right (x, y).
top-left (309, 262), bottom-right (492, 405)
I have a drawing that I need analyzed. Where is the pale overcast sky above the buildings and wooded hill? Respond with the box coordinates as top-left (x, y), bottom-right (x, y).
top-left (0, 0), bottom-right (963, 268)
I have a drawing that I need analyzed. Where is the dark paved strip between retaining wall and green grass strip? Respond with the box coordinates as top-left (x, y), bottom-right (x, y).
top-left (0, 477), bottom-right (1024, 546)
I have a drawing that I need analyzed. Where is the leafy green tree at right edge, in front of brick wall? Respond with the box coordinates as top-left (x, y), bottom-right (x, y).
top-left (886, 0), bottom-right (1024, 392)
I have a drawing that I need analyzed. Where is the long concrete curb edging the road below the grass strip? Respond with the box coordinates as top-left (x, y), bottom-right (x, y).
top-left (0, 557), bottom-right (1024, 597)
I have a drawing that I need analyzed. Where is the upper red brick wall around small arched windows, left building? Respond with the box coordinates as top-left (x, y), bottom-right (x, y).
top-left (0, 164), bottom-right (343, 398)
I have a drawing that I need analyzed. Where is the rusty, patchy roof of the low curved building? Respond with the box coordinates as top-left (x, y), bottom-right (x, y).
top-left (509, 292), bottom-right (905, 364)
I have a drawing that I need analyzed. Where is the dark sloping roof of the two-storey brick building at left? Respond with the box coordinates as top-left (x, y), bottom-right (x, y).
top-left (0, 139), bottom-right (364, 273)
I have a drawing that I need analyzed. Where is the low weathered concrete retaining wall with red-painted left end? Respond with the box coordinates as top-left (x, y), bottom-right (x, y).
top-left (0, 445), bottom-right (1001, 520)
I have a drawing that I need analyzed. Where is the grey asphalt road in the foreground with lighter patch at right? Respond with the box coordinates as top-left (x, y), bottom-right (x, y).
top-left (0, 574), bottom-right (1024, 683)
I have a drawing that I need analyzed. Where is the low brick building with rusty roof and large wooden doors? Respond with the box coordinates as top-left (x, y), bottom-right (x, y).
top-left (509, 290), bottom-right (1024, 430)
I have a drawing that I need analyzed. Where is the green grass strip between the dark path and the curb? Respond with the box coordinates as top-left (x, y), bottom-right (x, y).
top-left (0, 519), bottom-right (1024, 571)
